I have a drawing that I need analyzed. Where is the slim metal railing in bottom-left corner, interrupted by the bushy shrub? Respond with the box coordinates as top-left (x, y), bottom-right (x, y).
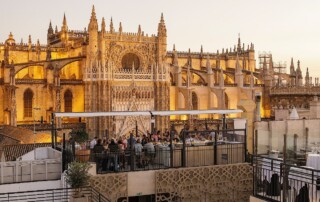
top-left (0, 187), bottom-right (110, 202)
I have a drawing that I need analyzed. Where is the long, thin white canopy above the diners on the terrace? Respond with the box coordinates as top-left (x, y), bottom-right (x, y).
top-left (53, 109), bottom-right (243, 117)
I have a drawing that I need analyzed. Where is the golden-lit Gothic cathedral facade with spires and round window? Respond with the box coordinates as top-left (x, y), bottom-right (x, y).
top-left (0, 7), bottom-right (270, 136)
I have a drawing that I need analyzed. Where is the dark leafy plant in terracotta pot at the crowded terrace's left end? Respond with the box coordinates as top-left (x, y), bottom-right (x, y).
top-left (70, 129), bottom-right (90, 162)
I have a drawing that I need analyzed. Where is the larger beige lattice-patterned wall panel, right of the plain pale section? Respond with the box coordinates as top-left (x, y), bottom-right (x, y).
top-left (156, 164), bottom-right (252, 202)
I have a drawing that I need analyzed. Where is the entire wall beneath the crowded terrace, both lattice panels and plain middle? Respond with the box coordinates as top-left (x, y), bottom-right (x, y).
top-left (90, 164), bottom-right (253, 202)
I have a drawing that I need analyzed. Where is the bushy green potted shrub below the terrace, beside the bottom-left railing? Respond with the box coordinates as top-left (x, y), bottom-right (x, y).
top-left (65, 161), bottom-right (91, 201)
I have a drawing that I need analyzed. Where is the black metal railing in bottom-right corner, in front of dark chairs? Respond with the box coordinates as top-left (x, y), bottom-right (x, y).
top-left (253, 156), bottom-right (320, 202)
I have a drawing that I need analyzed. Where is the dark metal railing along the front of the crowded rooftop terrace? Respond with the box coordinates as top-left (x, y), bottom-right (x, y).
top-left (63, 129), bottom-right (247, 174)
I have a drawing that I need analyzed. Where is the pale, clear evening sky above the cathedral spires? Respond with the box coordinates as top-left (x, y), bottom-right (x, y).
top-left (0, 0), bottom-right (320, 77)
